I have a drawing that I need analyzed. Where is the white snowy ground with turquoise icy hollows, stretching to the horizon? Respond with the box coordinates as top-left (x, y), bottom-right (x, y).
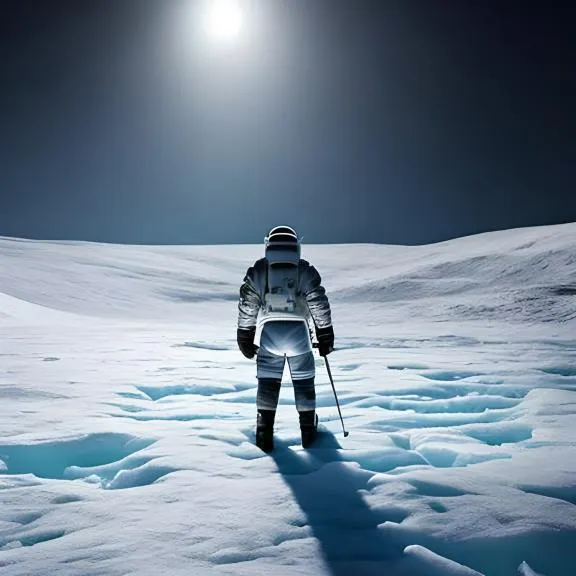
top-left (0, 224), bottom-right (576, 576)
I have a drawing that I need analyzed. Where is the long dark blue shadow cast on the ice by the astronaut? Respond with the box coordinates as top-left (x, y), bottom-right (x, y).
top-left (271, 431), bottom-right (402, 576)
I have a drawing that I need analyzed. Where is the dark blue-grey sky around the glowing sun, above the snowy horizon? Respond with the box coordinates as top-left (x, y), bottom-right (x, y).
top-left (0, 0), bottom-right (576, 244)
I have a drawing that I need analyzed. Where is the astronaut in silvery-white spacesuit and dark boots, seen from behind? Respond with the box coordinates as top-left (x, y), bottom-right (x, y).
top-left (237, 226), bottom-right (334, 452)
